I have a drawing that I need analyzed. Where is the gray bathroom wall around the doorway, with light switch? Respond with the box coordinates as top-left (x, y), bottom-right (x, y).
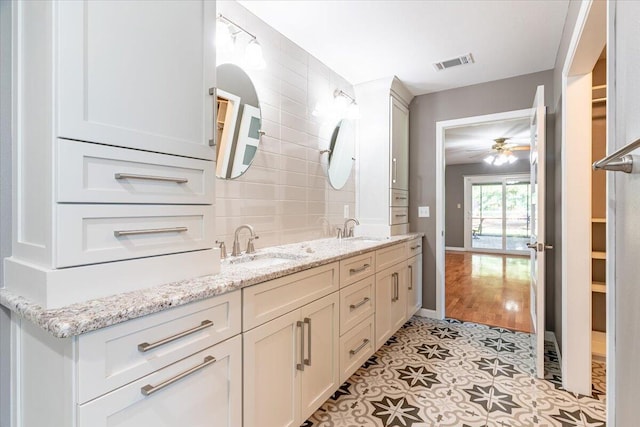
top-left (409, 70), bottom-right (555, 330)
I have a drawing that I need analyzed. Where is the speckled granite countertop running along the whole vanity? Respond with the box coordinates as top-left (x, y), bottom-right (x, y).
top-left (0, 233), bottom-right (423, 338)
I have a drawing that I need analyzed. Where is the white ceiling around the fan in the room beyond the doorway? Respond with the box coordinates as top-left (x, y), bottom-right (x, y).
top-left (445, 118), bottom-right (531, 165)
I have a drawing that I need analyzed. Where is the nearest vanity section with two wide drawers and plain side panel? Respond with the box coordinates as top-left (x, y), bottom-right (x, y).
top-left (13, 291), bottom-right (242, 427)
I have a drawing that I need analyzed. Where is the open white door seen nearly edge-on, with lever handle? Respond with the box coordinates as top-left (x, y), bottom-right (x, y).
top-left (527, 86), bottom-right (550, 378)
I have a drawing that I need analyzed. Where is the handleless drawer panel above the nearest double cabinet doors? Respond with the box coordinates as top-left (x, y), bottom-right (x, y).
top-left (242, 262), bottom-right (339, 331)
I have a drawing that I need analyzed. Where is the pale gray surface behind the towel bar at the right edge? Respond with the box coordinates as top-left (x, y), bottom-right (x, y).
top-left (607, 2), bottom-right (640, 426)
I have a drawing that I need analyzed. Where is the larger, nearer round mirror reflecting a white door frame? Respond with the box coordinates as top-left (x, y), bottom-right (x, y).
top-left (216, 64), bottom-right (262, 179)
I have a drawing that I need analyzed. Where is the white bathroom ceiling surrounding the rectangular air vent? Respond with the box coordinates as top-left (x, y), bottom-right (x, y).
top-left (240, 0), bottom-right (569, 95)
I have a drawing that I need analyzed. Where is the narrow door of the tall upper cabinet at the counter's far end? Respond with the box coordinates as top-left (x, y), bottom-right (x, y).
top-left (389, 96), bottom-right (409, 190)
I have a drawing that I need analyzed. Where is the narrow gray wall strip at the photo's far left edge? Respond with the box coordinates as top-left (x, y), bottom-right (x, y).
top-left (0, 0), bottom-right (11, 427)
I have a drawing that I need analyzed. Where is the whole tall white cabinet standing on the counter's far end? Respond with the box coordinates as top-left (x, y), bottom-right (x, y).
top-left (355, 77), bottom-right (413, 237)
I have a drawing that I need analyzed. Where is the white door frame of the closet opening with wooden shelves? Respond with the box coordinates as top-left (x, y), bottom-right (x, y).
top-left (561, 1), bottom-right (613, 402)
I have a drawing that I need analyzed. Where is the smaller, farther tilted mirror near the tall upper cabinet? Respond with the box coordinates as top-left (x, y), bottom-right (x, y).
top-left (327, 119), bottom-right (356, 190)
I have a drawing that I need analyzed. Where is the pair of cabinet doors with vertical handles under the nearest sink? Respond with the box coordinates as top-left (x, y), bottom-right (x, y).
top-left (243, 292), bottom-right (340, 427)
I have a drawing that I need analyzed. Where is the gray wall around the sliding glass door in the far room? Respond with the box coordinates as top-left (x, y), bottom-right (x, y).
top-left (444, 160), bottom-right (530, 248)
